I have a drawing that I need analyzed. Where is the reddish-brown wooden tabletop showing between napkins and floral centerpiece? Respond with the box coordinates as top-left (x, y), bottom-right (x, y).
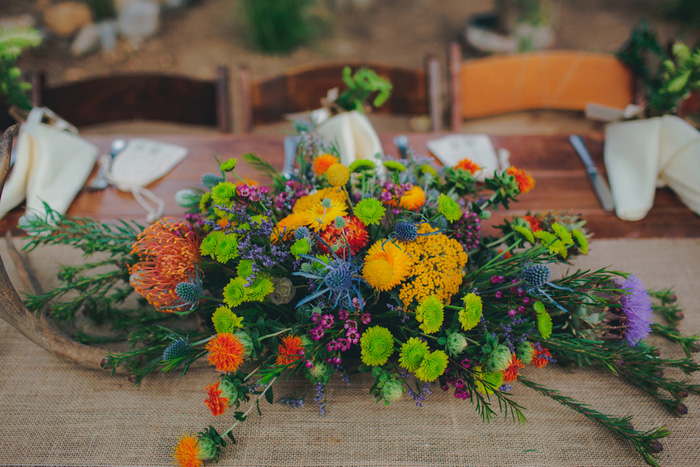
top-left (0, 133), bottom-right (700, 238)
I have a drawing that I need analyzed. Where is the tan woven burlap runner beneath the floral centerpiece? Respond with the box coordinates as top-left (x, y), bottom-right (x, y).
top-left (0, 240), bottom-right (700, 466)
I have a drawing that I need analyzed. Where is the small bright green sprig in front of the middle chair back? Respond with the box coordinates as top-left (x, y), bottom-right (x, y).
top-left (335, 67), bottom-right (392, 112)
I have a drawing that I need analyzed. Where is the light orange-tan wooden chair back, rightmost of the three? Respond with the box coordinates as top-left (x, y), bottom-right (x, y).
top-left (450, 44), bottom-right (635, 130)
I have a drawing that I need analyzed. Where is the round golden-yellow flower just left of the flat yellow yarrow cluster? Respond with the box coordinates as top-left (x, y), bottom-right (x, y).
top-left (362, 240), bottom-right (413, 290)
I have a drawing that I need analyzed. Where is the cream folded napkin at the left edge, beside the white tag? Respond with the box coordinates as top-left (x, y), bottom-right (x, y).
top-left (0, 108), bottom-right (98, 222)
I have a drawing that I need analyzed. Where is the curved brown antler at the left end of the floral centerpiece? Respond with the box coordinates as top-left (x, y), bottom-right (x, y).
top-left (0, 125), bottom-right (126, 373)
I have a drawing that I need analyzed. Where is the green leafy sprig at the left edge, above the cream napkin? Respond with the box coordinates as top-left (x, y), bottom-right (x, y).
top-left (0, 27), bottom-right (41, 110)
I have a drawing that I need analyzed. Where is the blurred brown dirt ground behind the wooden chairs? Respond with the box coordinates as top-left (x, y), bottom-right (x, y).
top-left (6, 0), bottom-right (700, 133)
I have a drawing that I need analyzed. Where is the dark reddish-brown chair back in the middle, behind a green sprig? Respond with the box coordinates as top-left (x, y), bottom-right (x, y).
top-left (239, 56), bottom-right (442, 132)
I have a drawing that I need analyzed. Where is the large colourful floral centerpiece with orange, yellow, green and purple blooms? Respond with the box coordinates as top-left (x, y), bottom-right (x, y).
top-left (21, 128), bottom-right (700, 466)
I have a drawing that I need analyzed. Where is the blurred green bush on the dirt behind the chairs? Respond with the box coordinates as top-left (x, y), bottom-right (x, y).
top-left (241, 0), bottom-right (320, 54)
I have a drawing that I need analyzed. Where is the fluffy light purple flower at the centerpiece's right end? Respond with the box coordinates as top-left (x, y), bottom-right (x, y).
top-left (618, 274), bottom-right (651, 346)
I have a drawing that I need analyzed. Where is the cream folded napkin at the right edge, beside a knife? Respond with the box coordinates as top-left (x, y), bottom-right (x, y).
top-left (604, 115), bottom-right (700, 221)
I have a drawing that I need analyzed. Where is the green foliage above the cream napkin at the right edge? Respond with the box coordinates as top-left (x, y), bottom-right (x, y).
top-left (617, 22), bottom-right (700, 116)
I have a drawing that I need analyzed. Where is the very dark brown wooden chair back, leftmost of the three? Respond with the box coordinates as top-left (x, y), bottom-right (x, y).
top-left (32, 66), bottom-right (232, 133)
